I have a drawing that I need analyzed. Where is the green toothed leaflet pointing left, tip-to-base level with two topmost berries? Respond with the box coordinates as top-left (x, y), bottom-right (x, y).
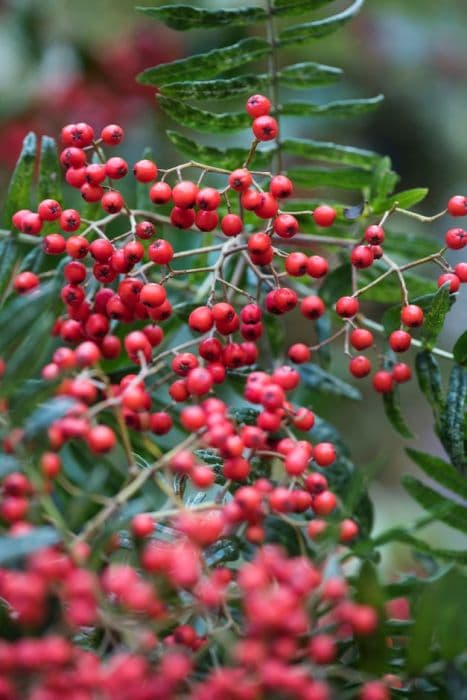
top-left (158, 95), bottom-right (251, 134)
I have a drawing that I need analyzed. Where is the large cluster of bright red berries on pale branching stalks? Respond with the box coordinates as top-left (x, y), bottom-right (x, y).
top-left (0, 95), bottom-right (467, 700)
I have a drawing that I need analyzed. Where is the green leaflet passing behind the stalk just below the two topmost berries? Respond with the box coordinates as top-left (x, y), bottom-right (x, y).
top-left (167, 131), bottom-right (273, 170)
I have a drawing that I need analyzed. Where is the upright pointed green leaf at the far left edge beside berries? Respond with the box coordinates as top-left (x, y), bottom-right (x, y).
top-left (1, 131), bottom-right (37, 229)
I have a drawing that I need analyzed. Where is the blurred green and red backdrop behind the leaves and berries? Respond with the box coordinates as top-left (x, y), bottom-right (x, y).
top-left (0, 0), bottom-right (467, 564)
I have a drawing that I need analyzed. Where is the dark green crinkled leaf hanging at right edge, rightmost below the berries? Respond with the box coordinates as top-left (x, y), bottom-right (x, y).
top-left (440, 365), bottom-right (467, 472)
